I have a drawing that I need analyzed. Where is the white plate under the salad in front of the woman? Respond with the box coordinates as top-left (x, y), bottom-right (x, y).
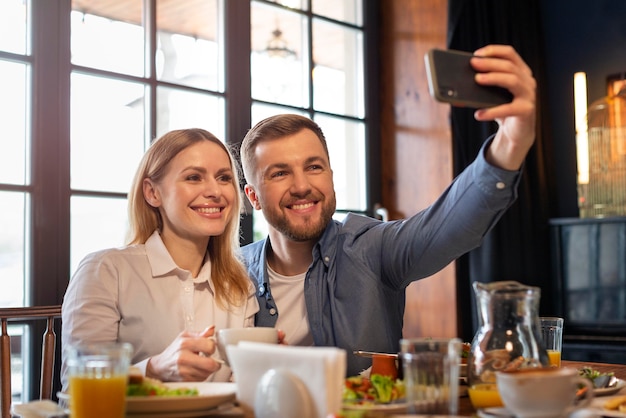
top-left (126, 382), bottom-right (237, 417)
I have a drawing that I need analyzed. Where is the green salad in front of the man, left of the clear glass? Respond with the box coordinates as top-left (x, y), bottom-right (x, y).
top-left (343, 374), bottom-right (404, 404)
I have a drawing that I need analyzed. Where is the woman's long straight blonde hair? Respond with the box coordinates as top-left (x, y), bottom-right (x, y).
top-left (128, 128), bottom-right (250, 309)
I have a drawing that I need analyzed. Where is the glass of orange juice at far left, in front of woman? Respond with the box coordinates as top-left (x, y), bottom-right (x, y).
top-left (67, 343), bottom-right (133, 418)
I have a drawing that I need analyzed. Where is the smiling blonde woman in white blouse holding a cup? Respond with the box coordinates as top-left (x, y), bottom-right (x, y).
top-left (61, 129), bottom-right (254, 389)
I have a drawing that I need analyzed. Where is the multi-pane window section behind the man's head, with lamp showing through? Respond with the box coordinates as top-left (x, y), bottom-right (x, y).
top-left (251, 0), bottom-right (369, 240)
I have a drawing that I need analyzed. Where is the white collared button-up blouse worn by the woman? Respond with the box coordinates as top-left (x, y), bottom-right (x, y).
top-left (61, 231), bottom-right (259, 390)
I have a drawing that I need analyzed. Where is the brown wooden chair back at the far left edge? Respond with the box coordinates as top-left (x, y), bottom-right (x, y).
top-left (0, 305), bottom-right (61, 418)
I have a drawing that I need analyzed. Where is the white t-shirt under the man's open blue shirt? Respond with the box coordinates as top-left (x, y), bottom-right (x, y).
top-left (267, 265), bottom-right (313, 346)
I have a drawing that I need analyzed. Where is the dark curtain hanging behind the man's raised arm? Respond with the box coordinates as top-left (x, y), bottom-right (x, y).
top-left (448, 0), bottom-right (554, 341)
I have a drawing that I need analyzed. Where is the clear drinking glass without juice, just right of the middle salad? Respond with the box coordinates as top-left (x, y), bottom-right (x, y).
top-left (400, 338), bottom-right (461, 415)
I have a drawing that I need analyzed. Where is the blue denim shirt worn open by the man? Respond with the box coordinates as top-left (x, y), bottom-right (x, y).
top-left (242, 141), bottom-right (521, 376)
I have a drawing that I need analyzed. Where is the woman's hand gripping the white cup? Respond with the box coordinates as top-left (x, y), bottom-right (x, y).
top-left (146, 326), bottom-right (222, 382)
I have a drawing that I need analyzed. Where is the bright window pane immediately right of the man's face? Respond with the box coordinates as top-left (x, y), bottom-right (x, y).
top-left (314, 115), bottom-right (367, 211)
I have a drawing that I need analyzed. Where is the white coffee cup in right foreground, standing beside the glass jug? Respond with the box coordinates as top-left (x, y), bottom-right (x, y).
top-left (496, 367), bottom-right (593, 418)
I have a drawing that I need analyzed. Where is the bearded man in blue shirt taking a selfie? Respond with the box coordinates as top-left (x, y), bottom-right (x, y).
top-left (241, 45), bottom-right (536, 375)
